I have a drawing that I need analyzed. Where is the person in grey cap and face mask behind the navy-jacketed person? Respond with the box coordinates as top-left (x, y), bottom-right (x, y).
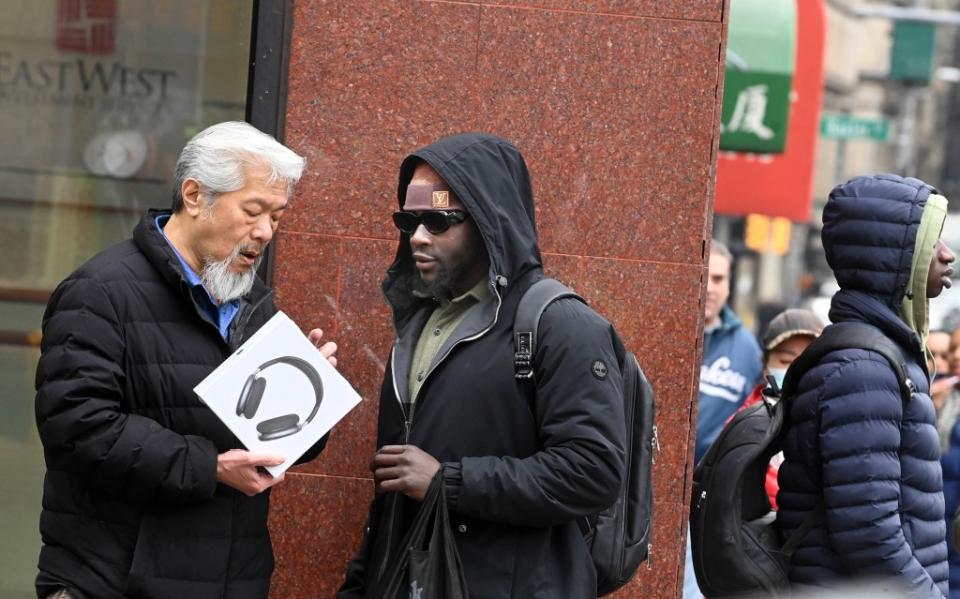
top-left (731, 308), bottom-right (823, 509)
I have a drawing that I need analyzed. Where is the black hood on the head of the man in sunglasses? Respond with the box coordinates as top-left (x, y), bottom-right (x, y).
top-left (382, 133), bottom-right (543, 318)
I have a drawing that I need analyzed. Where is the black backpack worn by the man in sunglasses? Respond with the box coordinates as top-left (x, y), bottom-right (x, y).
top-left (513, 279), bottom-right (660, 595)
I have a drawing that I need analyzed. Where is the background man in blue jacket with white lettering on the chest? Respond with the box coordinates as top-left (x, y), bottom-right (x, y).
top-left (683, 240), bottom-right (763, 599)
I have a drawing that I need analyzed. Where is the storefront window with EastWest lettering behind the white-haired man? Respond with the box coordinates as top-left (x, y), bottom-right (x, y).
top-left (0, 0), bottom-right (253, 598)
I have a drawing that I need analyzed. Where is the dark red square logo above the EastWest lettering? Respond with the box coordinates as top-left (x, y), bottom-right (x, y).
top-left (57, 0), bottom-right (117, 54)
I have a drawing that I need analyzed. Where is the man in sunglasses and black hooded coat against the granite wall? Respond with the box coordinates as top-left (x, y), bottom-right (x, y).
top-left (339, 134), bottom-right (625, 599)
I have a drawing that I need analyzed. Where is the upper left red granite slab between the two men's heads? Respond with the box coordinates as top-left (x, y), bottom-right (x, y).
top-left (284, 0), bottom-right (480, 238)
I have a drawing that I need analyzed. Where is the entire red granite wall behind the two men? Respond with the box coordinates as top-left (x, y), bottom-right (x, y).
top-left (270, 0), bottom-right (725, 599)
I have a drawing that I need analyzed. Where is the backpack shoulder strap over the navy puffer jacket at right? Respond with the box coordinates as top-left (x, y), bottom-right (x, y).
top-left (781, 322), bottom-right (916, 404)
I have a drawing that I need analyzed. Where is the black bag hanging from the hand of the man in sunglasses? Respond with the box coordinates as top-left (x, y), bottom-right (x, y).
top-left (376, 469), bottom-right (469, 599)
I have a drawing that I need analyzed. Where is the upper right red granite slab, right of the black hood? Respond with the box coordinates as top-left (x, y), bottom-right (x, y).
top-left (478, 7), bottom-right (720, 264)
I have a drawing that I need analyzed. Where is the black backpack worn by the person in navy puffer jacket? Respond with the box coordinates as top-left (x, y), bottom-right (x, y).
top-left (690, 322), bottom-right (915, 599)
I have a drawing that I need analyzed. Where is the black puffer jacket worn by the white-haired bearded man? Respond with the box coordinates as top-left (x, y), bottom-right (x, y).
top-left (36, 211), bottom-right (320, 599)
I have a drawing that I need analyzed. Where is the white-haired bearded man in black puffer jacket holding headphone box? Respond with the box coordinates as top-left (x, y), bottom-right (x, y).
top-left (36, 122), bottom-right (336, 599)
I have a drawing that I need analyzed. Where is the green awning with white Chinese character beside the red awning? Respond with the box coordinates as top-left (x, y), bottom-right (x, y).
top-left (720, 0), bottom-right (802, 154)
